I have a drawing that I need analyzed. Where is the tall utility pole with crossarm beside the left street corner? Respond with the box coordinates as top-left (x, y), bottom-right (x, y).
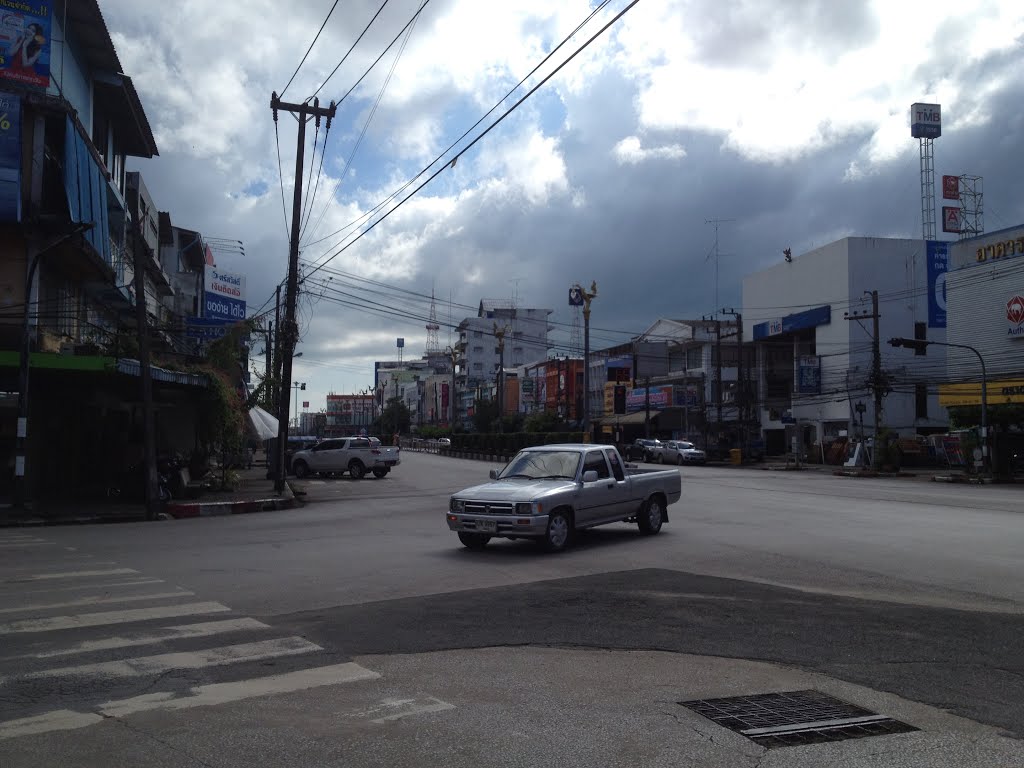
top-left (270, 92), bottom-right (336, 494)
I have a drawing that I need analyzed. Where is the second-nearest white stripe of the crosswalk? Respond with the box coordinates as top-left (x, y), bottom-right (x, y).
top-left (14, 637), bottom-right (324, 680)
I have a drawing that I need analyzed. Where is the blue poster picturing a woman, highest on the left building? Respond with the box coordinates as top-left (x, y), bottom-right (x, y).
top-left (0, 0), bottom-right (53, 90)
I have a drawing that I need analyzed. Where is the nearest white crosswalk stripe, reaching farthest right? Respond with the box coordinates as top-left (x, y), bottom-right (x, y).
top-left (99, 662), bottom-right (380, 717)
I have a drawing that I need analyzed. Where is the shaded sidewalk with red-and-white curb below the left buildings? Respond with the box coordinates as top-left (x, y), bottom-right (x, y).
top-left (0, 463), bottom-right (301, 527)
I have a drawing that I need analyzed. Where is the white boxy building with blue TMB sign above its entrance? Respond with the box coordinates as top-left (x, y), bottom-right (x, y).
top-left (742, 238), bottom-right (948, 455)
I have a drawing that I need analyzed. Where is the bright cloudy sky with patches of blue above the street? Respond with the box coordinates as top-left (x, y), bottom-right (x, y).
top-left (100, 0), bottom-right (1024, 410)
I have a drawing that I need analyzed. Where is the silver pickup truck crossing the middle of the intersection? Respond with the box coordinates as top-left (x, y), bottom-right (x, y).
top-left (447, 443), bottom-right (681, 552)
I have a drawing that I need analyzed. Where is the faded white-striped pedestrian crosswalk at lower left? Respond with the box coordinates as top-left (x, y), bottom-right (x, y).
top-left (0, 529), bottom-right (440, 742)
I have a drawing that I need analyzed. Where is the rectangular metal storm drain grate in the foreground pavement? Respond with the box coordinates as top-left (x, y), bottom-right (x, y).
top-left (679, 690), bottom-right (918, 746)
